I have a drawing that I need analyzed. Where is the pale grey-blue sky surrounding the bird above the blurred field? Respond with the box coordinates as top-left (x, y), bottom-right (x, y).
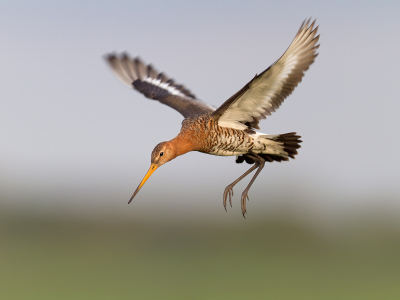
top-left (0, 1), bottom-right (400, 219)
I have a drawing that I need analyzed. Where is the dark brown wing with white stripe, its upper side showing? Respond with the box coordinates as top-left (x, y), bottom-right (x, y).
top-left (106, 53), bottom-right (215, 118)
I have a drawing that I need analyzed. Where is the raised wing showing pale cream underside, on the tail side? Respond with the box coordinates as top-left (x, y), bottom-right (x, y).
top-left (211, 20), bottom-right (319, 131)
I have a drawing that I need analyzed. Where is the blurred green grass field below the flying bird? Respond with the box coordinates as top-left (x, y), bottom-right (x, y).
top-left (0, 209), bottom-right (400, 300)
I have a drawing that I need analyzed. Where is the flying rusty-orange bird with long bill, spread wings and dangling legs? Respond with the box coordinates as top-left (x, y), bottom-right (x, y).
top-left (105, 18), bottom-right (319, 217)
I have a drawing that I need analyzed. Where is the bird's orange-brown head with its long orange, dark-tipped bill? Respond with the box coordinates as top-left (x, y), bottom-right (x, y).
top-left (128, 141), bottom-right (177, 203)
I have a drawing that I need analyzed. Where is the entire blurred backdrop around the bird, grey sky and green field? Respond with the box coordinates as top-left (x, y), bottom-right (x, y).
top-left (0, 0), bottom-right (400, 300)
